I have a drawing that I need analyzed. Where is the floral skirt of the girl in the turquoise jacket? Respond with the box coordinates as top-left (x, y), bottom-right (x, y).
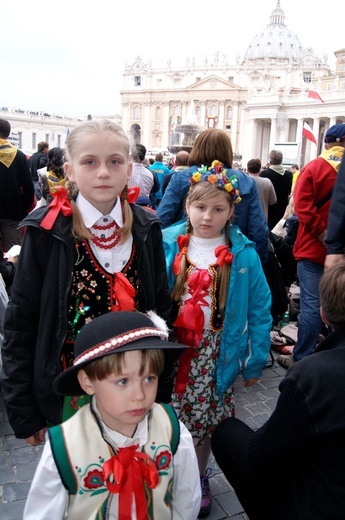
top-left (172, 330), bottom-right (235, 447)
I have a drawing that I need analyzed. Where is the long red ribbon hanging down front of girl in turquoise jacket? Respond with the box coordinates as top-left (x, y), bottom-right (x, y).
top-left (174, 269), bottom-right (212, 394)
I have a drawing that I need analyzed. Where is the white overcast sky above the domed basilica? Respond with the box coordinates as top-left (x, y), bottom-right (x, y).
top-left (0, 0), bottom-right (345, 118)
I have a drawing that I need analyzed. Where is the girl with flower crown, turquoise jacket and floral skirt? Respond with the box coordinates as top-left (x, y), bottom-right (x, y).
top-left (163, 161), bottom-right (272, 517)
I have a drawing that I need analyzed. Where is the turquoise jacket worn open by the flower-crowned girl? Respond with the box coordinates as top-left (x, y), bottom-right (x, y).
top-left (163, 221), bottom-right (272, 397)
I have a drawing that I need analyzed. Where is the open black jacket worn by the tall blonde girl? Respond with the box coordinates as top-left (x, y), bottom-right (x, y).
top-left (1, 205), bottom-right (170, 438)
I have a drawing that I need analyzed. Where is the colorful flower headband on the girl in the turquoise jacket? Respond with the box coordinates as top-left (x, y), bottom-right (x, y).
top-left (189, 160), bottom-right (241, 204)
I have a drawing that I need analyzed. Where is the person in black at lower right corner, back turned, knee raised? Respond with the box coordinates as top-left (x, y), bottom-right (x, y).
top-left (212, 260), bottom-right (345, 520)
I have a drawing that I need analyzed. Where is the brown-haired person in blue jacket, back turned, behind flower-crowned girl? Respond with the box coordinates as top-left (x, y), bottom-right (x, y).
top-left (157, 128), bottom-right (268, 264)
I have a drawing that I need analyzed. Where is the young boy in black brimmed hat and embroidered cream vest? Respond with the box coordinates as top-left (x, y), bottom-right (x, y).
top-left (24, 311), bottom-right (201, 520)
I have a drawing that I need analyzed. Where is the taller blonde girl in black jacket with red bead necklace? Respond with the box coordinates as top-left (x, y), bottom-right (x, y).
top-left (1, 120), bottom-right (173, 445)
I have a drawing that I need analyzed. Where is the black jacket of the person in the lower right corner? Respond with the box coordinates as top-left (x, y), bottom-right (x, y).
top-left (249, 328), bottom-right (345, 520)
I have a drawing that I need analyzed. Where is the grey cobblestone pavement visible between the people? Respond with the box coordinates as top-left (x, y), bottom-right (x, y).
top-left (0, 354), bottom-right (286, 520)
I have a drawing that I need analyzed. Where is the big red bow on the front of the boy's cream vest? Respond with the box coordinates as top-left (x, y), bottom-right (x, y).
top-left (103, 446), bottom-right (159, 520)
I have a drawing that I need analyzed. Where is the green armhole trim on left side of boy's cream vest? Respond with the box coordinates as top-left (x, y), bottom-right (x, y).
top-left (48, 424), bottom-right (77, 495)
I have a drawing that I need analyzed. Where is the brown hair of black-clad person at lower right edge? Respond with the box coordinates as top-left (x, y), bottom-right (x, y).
top-left (319, 259), bottom-right (345, 329)
